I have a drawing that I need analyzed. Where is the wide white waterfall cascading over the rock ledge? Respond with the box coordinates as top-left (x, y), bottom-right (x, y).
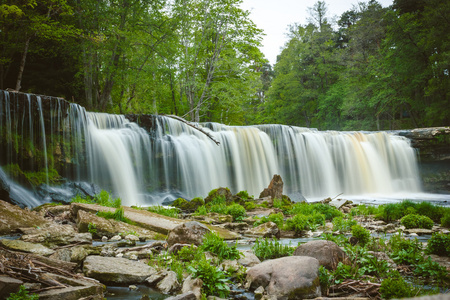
top-left (0, 91), bottom-right (421, 205)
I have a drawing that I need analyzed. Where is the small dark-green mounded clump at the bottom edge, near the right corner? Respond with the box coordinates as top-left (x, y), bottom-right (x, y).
top-left (380, 271), bottom-right (417, 299)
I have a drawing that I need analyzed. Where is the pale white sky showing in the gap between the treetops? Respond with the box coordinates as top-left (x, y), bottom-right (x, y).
top-left (241, 0), bottom-right (393, 65)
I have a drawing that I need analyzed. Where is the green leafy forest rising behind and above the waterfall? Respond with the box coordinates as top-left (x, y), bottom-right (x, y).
top-left (0, 0), bottom-right (450, 130)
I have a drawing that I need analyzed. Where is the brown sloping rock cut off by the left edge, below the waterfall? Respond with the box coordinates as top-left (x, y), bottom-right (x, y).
top-left (0, 200), bottom-right (47, 235)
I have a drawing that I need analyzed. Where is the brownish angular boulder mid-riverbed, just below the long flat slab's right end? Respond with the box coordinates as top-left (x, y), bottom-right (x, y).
top-left (167, 221), bottom-right (211, 247)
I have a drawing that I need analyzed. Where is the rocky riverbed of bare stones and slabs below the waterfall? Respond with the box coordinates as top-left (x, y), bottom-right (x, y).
top-left (0, 178), bottom-right (450, 299)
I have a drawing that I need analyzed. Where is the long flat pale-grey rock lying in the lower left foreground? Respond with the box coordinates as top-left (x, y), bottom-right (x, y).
top-left (83, 255), bottom-right (156, 284)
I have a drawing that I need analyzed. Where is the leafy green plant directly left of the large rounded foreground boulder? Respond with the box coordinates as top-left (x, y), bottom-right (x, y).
top-left (187, 258), bottom-right (230, 298)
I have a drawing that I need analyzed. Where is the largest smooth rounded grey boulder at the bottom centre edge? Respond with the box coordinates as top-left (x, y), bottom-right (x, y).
top-left (246, 256), bottom-right (321, 299)
